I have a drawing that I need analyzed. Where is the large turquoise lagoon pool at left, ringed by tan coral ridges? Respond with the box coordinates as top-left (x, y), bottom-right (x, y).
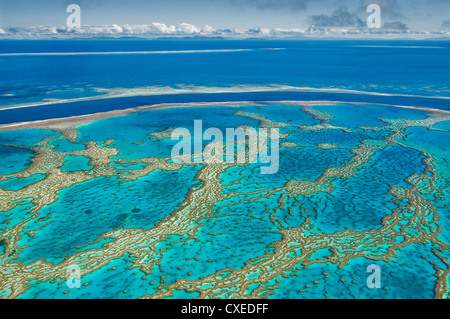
top-left (15, 168), bottom-right (200, 262)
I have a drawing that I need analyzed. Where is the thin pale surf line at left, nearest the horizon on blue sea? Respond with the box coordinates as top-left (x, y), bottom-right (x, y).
top-left (0, 49), bottom-right (254, 56)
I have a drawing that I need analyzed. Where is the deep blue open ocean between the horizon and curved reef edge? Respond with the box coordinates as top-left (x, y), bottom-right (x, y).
top-left (0, 40), bottom-right (450, 124)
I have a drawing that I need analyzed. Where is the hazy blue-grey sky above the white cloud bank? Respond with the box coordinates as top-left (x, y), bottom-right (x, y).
top-left (0, 0), bottom-right (450, 31)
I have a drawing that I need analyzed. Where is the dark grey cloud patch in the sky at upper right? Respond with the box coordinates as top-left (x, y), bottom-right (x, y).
top-left (309, 7), bottom-right (365, 28)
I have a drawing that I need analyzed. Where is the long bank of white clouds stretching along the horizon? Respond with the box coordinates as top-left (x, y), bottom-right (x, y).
top-left (0, 22), bottom-right (450, 39)
